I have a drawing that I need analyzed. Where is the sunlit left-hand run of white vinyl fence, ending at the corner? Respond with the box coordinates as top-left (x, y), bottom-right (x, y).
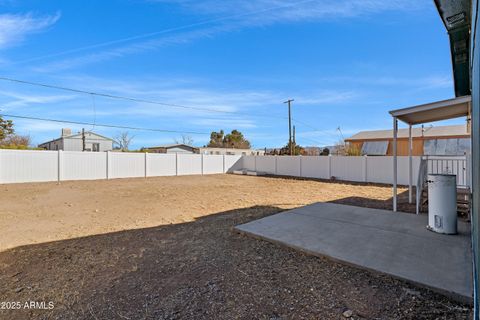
top-left (0, 150), bottom-right (242, 183)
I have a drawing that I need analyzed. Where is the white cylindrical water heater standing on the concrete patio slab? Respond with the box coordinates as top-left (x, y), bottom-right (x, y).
top-left (427, 174), bottom-right (457, 234)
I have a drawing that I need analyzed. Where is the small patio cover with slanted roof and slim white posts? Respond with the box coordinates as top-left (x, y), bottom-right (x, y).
top-left (390, 96), bottom-right (472, 213)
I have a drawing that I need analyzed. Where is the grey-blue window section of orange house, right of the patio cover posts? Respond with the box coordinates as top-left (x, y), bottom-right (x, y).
top-left (423, 138), bottom-right (470, 156)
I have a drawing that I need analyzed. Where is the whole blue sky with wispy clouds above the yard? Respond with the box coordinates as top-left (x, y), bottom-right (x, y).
top-left (0, 0), bottom-right (464, 148)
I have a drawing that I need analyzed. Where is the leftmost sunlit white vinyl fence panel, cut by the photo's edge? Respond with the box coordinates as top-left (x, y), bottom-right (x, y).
top-left (0, 150), bottom-right (58, 183)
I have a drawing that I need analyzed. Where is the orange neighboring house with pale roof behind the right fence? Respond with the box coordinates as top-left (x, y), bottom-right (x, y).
top-left (345, 125), bottom-right (470, 156)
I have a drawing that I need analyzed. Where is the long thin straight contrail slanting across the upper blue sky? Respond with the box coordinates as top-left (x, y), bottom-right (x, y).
top-left (16, 0), bottom-right (317, 64)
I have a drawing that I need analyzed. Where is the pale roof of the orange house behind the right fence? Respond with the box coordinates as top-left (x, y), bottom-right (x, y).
top-left (345, 125), bottom-right (469, 141)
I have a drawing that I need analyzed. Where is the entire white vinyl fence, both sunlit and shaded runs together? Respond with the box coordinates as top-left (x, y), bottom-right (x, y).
top-left (0, 149), bottom-right (420, 185)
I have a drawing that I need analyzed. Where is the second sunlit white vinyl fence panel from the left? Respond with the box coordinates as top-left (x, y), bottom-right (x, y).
top-left (61, 151), bottom-right (107, 180)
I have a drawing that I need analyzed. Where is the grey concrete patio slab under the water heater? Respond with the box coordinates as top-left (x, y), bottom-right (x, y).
top-left (236, 203), bottom-right (472, 302)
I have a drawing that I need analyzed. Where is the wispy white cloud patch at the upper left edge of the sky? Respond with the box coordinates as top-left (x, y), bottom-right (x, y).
top-left (0, 13), bottom-right (60, 50)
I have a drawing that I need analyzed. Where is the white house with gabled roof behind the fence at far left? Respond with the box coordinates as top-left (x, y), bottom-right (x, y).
top-left (38, 128), bottom-right (113, 152)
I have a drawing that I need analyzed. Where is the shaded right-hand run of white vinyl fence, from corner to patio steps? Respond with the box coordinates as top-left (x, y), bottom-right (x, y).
top-left (242, 156), bottom-right (420, 185)
